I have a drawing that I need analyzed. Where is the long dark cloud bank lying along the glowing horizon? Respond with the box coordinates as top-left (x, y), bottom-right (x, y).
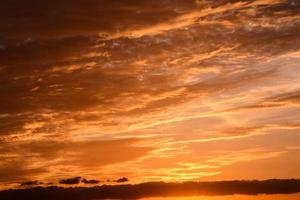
top-left (0, 179), bottom-right (300, 200)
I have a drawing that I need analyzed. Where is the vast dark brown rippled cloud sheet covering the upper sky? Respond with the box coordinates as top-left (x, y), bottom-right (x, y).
top-left (0, 0), bottom-right (300, 140)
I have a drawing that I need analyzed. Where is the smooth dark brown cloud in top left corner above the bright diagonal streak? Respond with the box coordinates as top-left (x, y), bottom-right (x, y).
top-left (0, 0), bottom-right (195, 39)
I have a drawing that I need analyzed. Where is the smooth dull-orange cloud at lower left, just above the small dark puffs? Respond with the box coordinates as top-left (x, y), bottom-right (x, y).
top-left (0, 139), bottom-right (152, 184)
